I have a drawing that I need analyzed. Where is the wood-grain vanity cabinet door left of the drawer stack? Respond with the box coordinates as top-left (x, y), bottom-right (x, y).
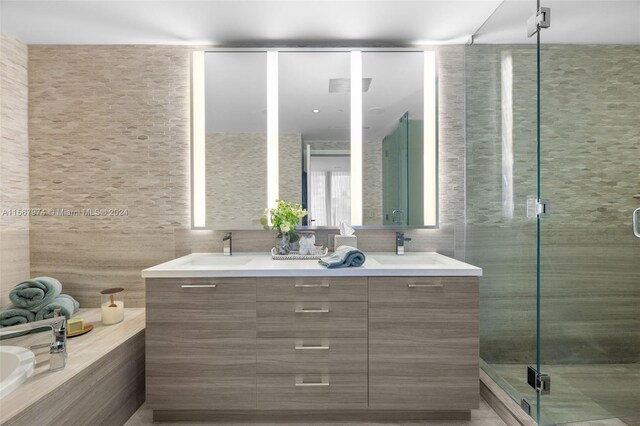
top-left (145, 278), bottom-right (256, 410)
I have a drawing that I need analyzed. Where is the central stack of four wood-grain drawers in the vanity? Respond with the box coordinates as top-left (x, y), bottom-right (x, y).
top-left (256, 277), bottom-right (368, 409)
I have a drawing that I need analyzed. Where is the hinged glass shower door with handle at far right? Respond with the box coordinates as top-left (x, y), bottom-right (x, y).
top-left (539, 0), bottom-right (640, 425)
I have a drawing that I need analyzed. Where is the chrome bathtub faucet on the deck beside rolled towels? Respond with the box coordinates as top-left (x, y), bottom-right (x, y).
top-left (0, 309), bottom-right (67, 371)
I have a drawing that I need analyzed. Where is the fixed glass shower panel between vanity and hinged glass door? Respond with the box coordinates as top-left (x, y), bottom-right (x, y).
top-left (465, 0), bottom-right (540, 418)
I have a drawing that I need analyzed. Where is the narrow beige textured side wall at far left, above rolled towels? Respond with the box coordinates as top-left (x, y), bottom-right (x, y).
top-left (0, 34), bottom-right (29, 306)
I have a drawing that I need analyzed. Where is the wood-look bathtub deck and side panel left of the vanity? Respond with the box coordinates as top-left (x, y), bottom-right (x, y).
top-left (0, 308), bottom-right (145, 426)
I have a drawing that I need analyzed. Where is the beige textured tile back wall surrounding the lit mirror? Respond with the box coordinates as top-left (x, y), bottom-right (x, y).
top-left (23, 45), bottom-right (465, 307)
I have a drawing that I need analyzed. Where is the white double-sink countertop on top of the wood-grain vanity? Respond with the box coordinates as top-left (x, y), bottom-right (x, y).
top-left (142, 252), bottom-right (482, 278)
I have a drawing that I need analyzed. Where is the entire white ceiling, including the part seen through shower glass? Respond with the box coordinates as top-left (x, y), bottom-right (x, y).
top-left (0, 0), bottom-right (640, 46)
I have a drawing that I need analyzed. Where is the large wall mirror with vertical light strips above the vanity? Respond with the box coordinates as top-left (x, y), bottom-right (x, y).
top-left (192, 49), bottom-right (438, 230)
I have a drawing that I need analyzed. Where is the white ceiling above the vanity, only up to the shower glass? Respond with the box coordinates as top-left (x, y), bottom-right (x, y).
top-left (1, 0), bottom-right (501, 46)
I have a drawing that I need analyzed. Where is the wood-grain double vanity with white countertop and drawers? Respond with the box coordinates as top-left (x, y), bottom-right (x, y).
top-left (142, 253), bottom-right (482, 421)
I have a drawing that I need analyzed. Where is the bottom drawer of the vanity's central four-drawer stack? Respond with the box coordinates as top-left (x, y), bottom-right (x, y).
top-left (258, 373), bottom-right (367, 410)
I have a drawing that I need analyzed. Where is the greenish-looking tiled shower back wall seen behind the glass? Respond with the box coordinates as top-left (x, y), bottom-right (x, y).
top-left (465, 45), bottom-right (640, 363)
